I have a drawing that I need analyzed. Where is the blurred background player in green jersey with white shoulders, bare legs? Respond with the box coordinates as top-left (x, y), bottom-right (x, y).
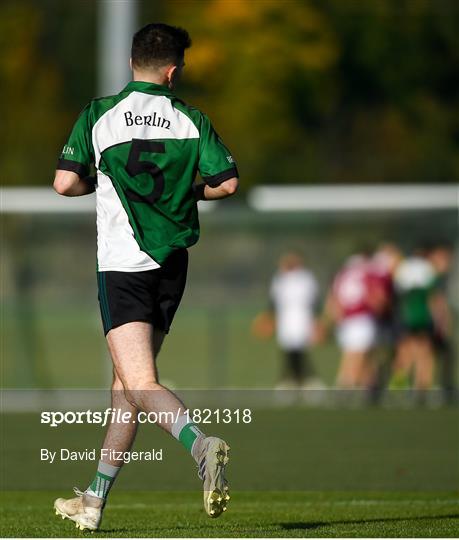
top-left (392, 250), bottom-right (436, 401)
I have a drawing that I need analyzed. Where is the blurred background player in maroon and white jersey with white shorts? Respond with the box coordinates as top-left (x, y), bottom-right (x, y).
top-left (326, 251), bottom-right (382, 389)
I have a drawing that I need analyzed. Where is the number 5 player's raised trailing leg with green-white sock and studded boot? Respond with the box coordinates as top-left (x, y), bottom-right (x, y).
top-left (107, 322), bottom-right (229, 517)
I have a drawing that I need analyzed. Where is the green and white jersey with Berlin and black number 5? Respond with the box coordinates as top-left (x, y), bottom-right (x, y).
top-left (57, 81), bottom-right (238, 272)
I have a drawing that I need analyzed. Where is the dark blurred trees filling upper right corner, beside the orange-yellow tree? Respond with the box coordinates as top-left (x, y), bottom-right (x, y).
top-left (320, 0), bottom-right (459, 182)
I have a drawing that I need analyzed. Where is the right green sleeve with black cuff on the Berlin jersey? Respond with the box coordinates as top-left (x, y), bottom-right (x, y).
top-left (198, 114), bottom-right (239, 187)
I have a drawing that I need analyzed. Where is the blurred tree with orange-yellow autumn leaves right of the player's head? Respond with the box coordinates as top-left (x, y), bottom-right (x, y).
top-left (153, 0), bottom-right (337, 187)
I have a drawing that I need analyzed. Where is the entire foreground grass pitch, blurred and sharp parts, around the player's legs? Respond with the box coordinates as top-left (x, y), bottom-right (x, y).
top-left (0, 408), bottom-right (459, 537)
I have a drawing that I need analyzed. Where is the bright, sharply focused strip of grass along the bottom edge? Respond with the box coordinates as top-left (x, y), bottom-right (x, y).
top-left (1, 491), bottom-right (459, 538)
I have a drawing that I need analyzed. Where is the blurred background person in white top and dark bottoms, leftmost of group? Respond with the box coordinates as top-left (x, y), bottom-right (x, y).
top-left (252, 252), bottom-right (322, 388)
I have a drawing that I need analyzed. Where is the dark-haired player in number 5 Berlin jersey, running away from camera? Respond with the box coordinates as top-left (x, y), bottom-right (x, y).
top-left (54, 24), bottom-right (238, 530)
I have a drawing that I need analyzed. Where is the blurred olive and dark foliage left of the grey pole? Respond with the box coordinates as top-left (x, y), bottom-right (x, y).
top-left (0, 0), bottom-right (94, 185)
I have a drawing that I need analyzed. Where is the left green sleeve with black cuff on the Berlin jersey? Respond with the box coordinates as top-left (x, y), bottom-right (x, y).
top-left (57, 104), bottom-right (94, 177)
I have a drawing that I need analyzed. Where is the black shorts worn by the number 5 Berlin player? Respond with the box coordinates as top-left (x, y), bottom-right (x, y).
top-left (97, 249), bottom-right (188, 335)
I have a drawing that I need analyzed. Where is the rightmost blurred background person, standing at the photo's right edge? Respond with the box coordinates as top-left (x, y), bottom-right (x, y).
top-left (428, 245), bottom-right (457, 403)
